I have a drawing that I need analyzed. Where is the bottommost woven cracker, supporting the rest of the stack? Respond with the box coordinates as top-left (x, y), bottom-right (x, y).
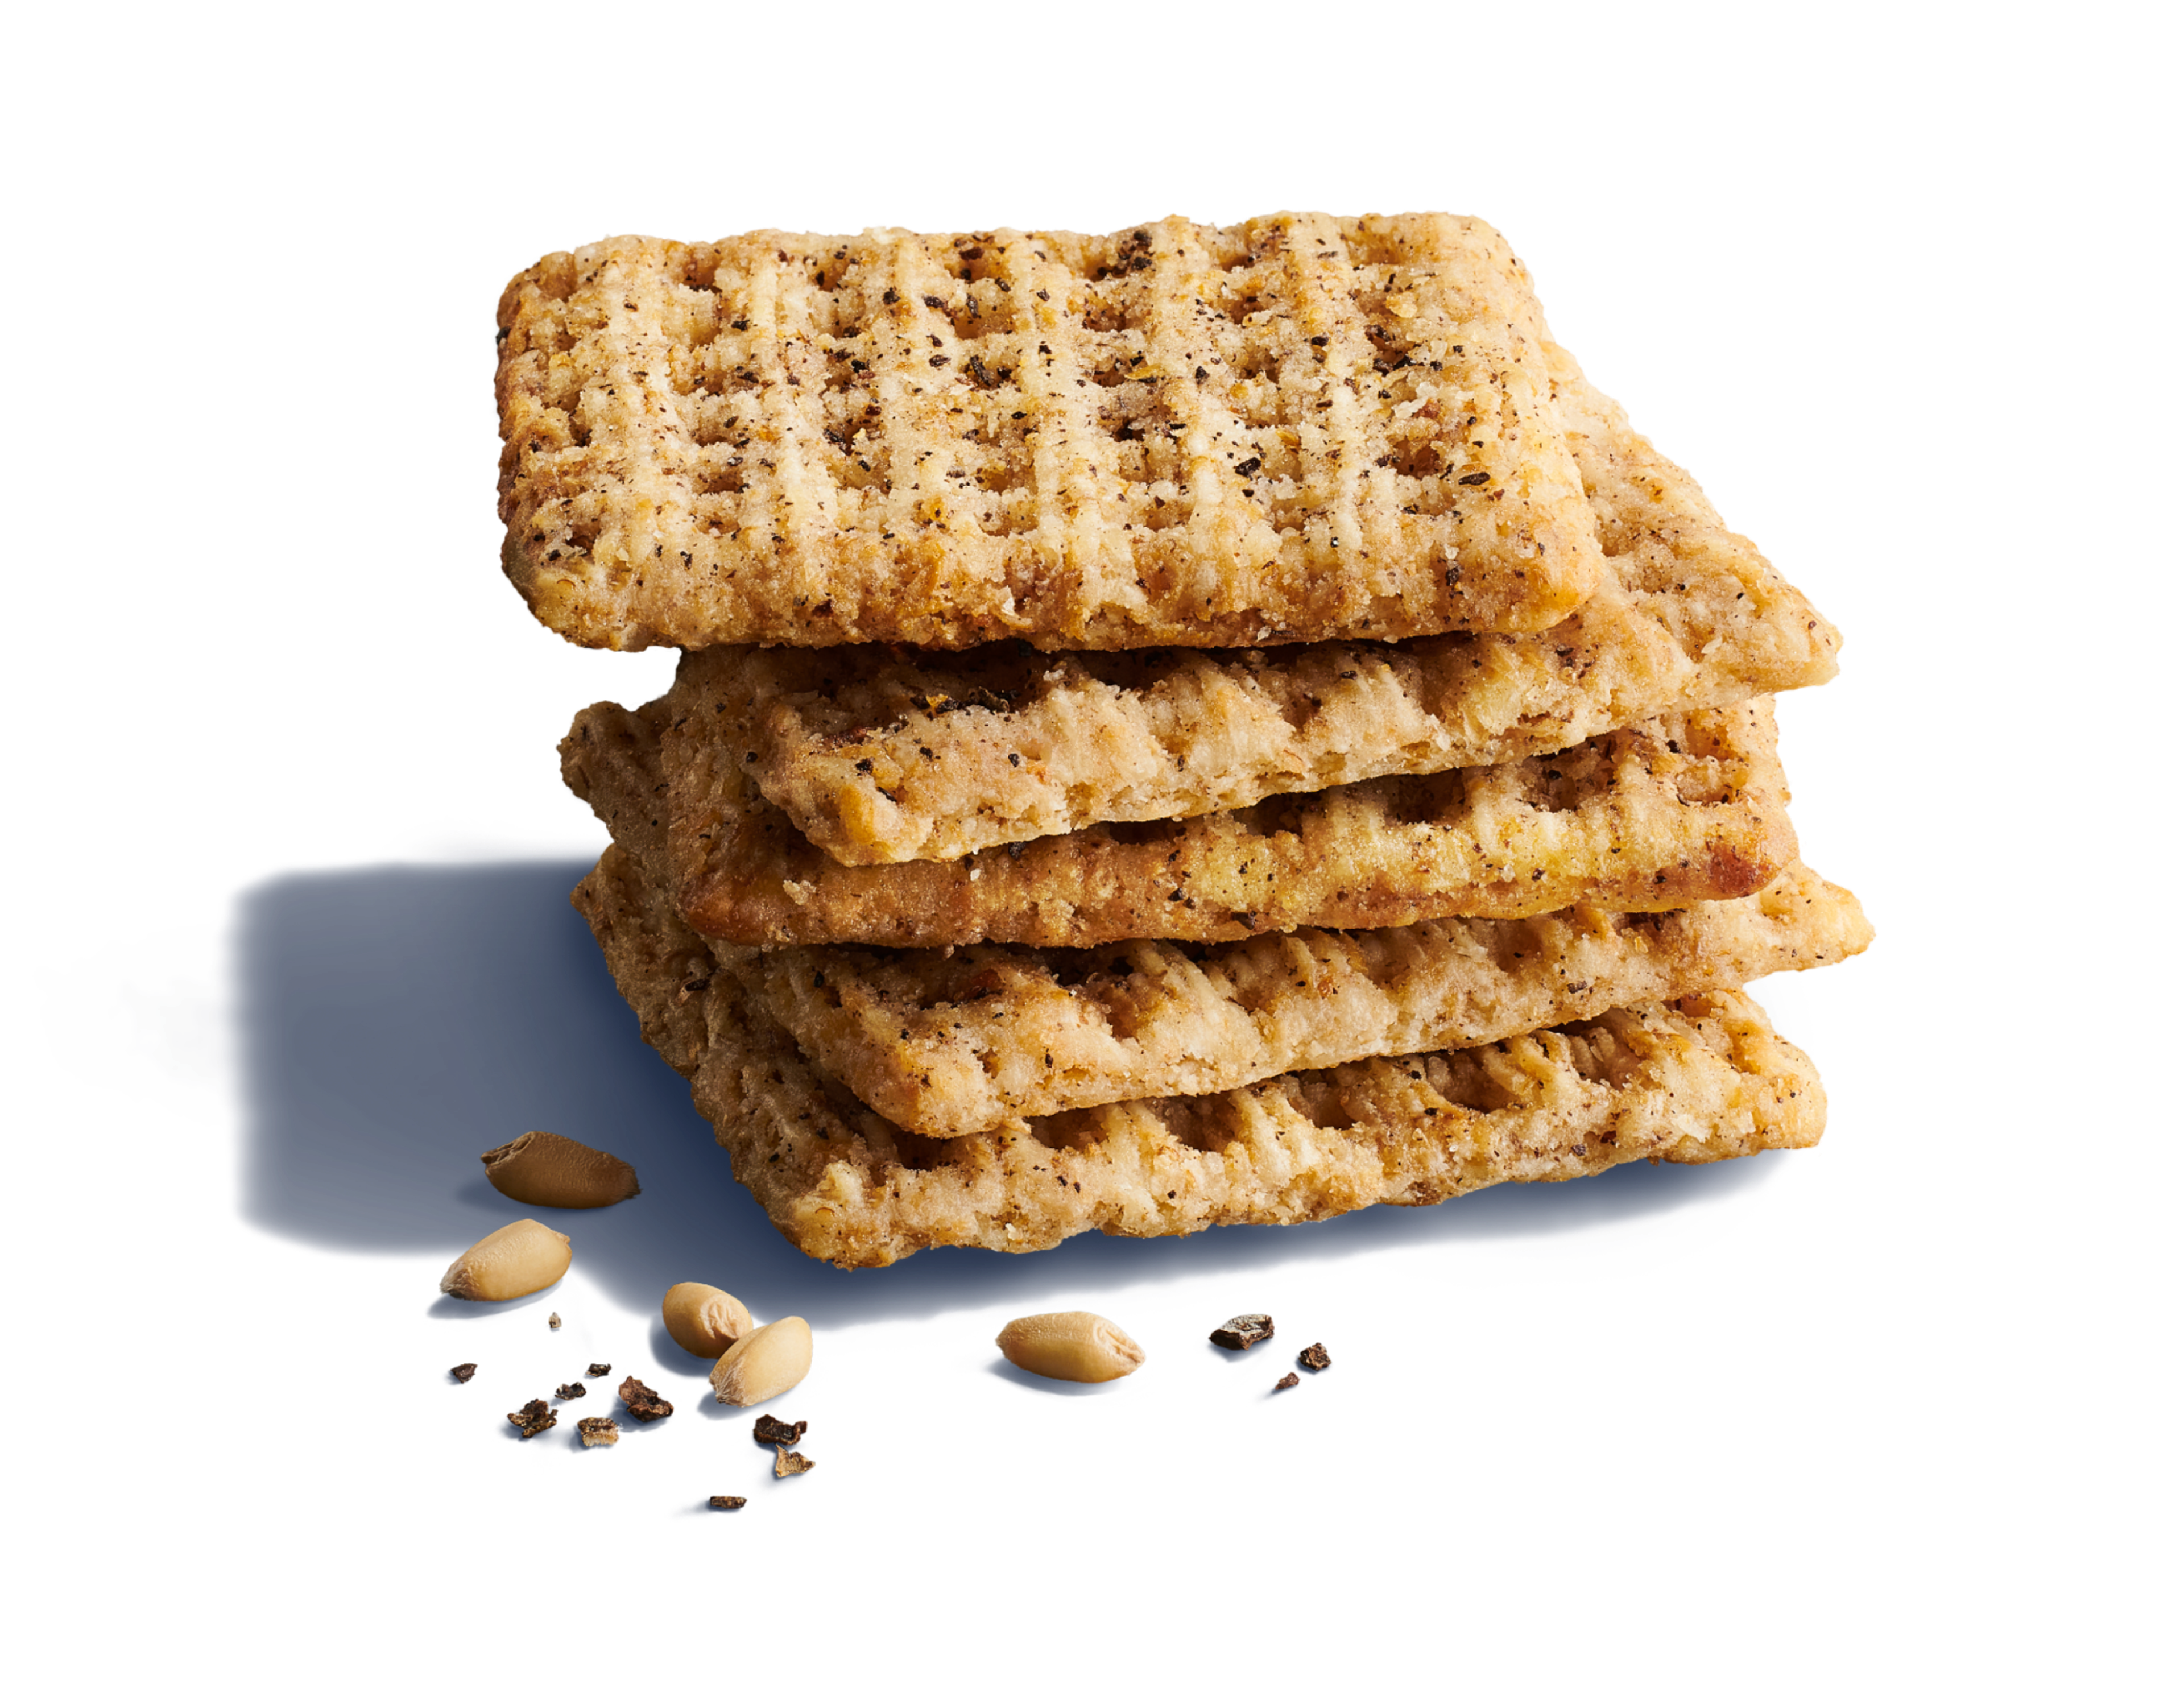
top-left (570, 845), bottom-right (1828, 1268)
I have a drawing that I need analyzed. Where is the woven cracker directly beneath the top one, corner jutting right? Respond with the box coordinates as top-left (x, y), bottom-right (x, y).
top-left (685, 341), bottom-right (1843, 864)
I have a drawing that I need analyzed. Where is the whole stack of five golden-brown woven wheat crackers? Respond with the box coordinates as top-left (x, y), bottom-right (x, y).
top-left (494, 212), bottom-right (1874, 1266)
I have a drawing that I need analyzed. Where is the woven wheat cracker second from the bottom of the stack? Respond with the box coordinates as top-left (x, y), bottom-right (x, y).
top-left (714, 862), bottom-right (1874, 1137)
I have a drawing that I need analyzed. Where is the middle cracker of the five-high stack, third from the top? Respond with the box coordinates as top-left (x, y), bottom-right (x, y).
top-left (557, 697), bottom-right (1797, 948)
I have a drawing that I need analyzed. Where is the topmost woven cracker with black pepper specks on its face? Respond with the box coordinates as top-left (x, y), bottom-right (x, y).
top-left (494, 212), bottom-right (1603, 651)
